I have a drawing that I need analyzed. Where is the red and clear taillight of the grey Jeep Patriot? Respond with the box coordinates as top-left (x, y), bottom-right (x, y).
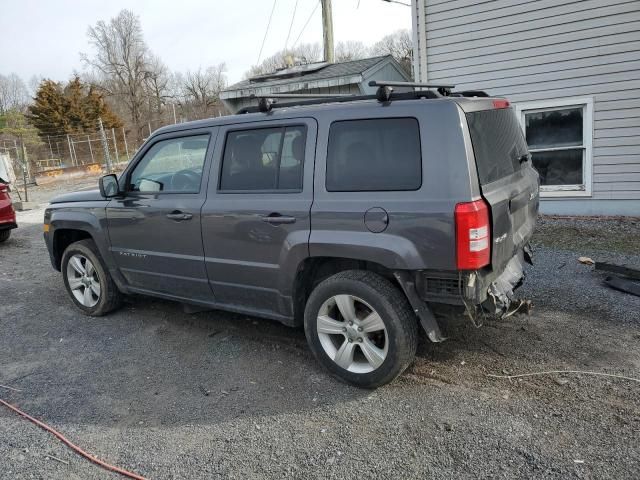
top-left (455, 200), bottom-right (491, 270)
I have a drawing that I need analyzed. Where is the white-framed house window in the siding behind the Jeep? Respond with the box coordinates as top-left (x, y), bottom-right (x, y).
top-left (516, 98), bottom-right (593, 197)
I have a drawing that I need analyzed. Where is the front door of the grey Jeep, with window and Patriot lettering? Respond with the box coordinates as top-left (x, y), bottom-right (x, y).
top-left (107, 130), bottom-right (216, 301)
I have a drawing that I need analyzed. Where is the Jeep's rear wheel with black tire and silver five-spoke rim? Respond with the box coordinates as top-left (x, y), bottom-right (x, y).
top-left (304, 270), bottom-right (418, 388)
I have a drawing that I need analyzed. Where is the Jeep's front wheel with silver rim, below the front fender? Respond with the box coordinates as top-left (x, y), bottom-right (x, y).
top-left (61, 240), bottom-right (122, 317)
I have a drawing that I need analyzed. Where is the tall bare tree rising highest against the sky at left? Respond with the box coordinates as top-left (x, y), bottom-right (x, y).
top-left (81, 10), bottom-right (153, 140)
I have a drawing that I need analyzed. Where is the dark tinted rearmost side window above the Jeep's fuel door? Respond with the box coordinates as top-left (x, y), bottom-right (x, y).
top-left (326, 118), bottom-right (422, 192)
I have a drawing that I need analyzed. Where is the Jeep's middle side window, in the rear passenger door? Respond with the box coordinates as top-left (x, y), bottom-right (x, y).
top-left (220, 125), bottom-right (307, 191)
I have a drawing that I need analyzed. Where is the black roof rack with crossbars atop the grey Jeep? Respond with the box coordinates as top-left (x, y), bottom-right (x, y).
top-left (236, 80), bottom-right (489, 114)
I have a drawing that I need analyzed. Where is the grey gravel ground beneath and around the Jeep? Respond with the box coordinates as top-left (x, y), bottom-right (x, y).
top-left (0, 181), bottom-right (640, 479)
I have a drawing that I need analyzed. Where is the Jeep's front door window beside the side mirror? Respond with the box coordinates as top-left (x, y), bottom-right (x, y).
top-left (128, 135), bottom-right (209, 193)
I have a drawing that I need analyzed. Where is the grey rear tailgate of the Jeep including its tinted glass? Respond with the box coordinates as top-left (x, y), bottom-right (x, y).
top-left (466, 104), bottom-right (539, 270)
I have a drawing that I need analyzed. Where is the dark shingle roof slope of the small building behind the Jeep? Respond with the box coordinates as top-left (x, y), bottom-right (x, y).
top-left (224, 55), bottom-right (391, 92)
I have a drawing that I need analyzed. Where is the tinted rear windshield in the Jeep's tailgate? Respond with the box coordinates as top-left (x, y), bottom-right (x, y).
top-left (467, 108), bottom-right (527, 185)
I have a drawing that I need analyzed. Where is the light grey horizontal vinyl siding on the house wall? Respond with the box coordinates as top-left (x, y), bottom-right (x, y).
top-left (414, 0), bottom-right (640, 208)
